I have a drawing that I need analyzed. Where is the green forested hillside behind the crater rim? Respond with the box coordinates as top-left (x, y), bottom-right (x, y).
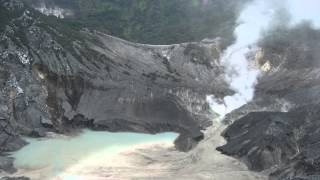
top-left (27, 0), bottom-right (248, 44)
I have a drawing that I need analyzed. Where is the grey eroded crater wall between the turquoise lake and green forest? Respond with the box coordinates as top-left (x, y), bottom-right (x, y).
top-left (0, 0), bottom-right (232, 172)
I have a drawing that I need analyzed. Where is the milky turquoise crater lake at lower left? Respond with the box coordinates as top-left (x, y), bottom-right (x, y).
top-left (8, 130), bottom-right (178, 179)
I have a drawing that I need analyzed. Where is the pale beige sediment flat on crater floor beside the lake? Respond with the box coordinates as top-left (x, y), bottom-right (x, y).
top-left (3, 123), bottom-right (267, 180)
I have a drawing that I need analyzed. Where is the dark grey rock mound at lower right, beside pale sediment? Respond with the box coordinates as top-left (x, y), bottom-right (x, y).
top-left (218, 106), bottom-right (320, 179)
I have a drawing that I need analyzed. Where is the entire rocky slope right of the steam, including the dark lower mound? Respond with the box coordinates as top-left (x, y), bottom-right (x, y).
top-left (218, 24), bottom-right (320, 180)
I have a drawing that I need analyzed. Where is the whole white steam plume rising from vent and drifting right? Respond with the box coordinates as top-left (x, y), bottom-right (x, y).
top-left (207, 0), bottom-right (320, 119)
